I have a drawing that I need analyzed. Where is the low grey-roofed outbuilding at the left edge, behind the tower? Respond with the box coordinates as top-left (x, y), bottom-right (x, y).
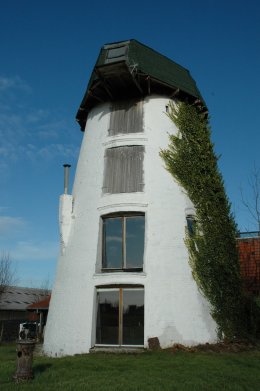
top-left (0, 286), bottom-right (49, 340)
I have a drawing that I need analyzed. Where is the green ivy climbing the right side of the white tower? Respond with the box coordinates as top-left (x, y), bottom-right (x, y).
top-left (160, 102), bottom-right (242, 338)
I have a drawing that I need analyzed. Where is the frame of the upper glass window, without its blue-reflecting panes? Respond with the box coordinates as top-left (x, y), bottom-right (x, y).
top-left (101, 212), bottom-right (145, 272)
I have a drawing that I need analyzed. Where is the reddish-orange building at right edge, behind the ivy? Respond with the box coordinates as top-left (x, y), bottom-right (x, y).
top-left (238, 232), bottom-right (260, 296)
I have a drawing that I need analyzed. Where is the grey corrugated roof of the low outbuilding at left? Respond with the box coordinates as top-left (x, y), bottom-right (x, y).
top-left (0, 286), bottom-right (49, 311)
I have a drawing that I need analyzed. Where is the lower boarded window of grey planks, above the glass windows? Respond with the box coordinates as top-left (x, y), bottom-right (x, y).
top-left (103, 145), bottom-right (144, 193)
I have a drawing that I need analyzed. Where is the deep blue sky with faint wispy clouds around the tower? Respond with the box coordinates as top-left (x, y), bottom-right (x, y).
top-left (0, 0), bottom-right (260, 286)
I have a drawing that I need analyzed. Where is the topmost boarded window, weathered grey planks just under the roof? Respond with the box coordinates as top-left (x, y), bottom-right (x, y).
top-left (108, 100), bottom-right (143, 136)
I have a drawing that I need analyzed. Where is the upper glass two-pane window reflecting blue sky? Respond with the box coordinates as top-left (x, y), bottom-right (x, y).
top-left (102, 214), bottom-right (145, 271)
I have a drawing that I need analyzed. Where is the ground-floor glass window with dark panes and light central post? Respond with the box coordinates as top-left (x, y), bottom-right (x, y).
top-left (96, 287), bottom-right (144, 345)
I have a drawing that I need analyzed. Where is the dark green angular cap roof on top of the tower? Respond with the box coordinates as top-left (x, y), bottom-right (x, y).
top-left (76, 39), bottom-right (206, 130)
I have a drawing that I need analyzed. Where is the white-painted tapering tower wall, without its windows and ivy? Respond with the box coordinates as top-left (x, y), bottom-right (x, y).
top-left (44, 96), bottom-right (216, 356)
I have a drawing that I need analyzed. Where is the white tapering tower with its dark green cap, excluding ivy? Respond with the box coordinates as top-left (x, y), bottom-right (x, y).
top-left (44, 40), bottom-right (216, 356)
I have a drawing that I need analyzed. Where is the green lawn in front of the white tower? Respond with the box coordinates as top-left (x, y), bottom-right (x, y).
top-left (0, 345), bottom-right (260, 391)
